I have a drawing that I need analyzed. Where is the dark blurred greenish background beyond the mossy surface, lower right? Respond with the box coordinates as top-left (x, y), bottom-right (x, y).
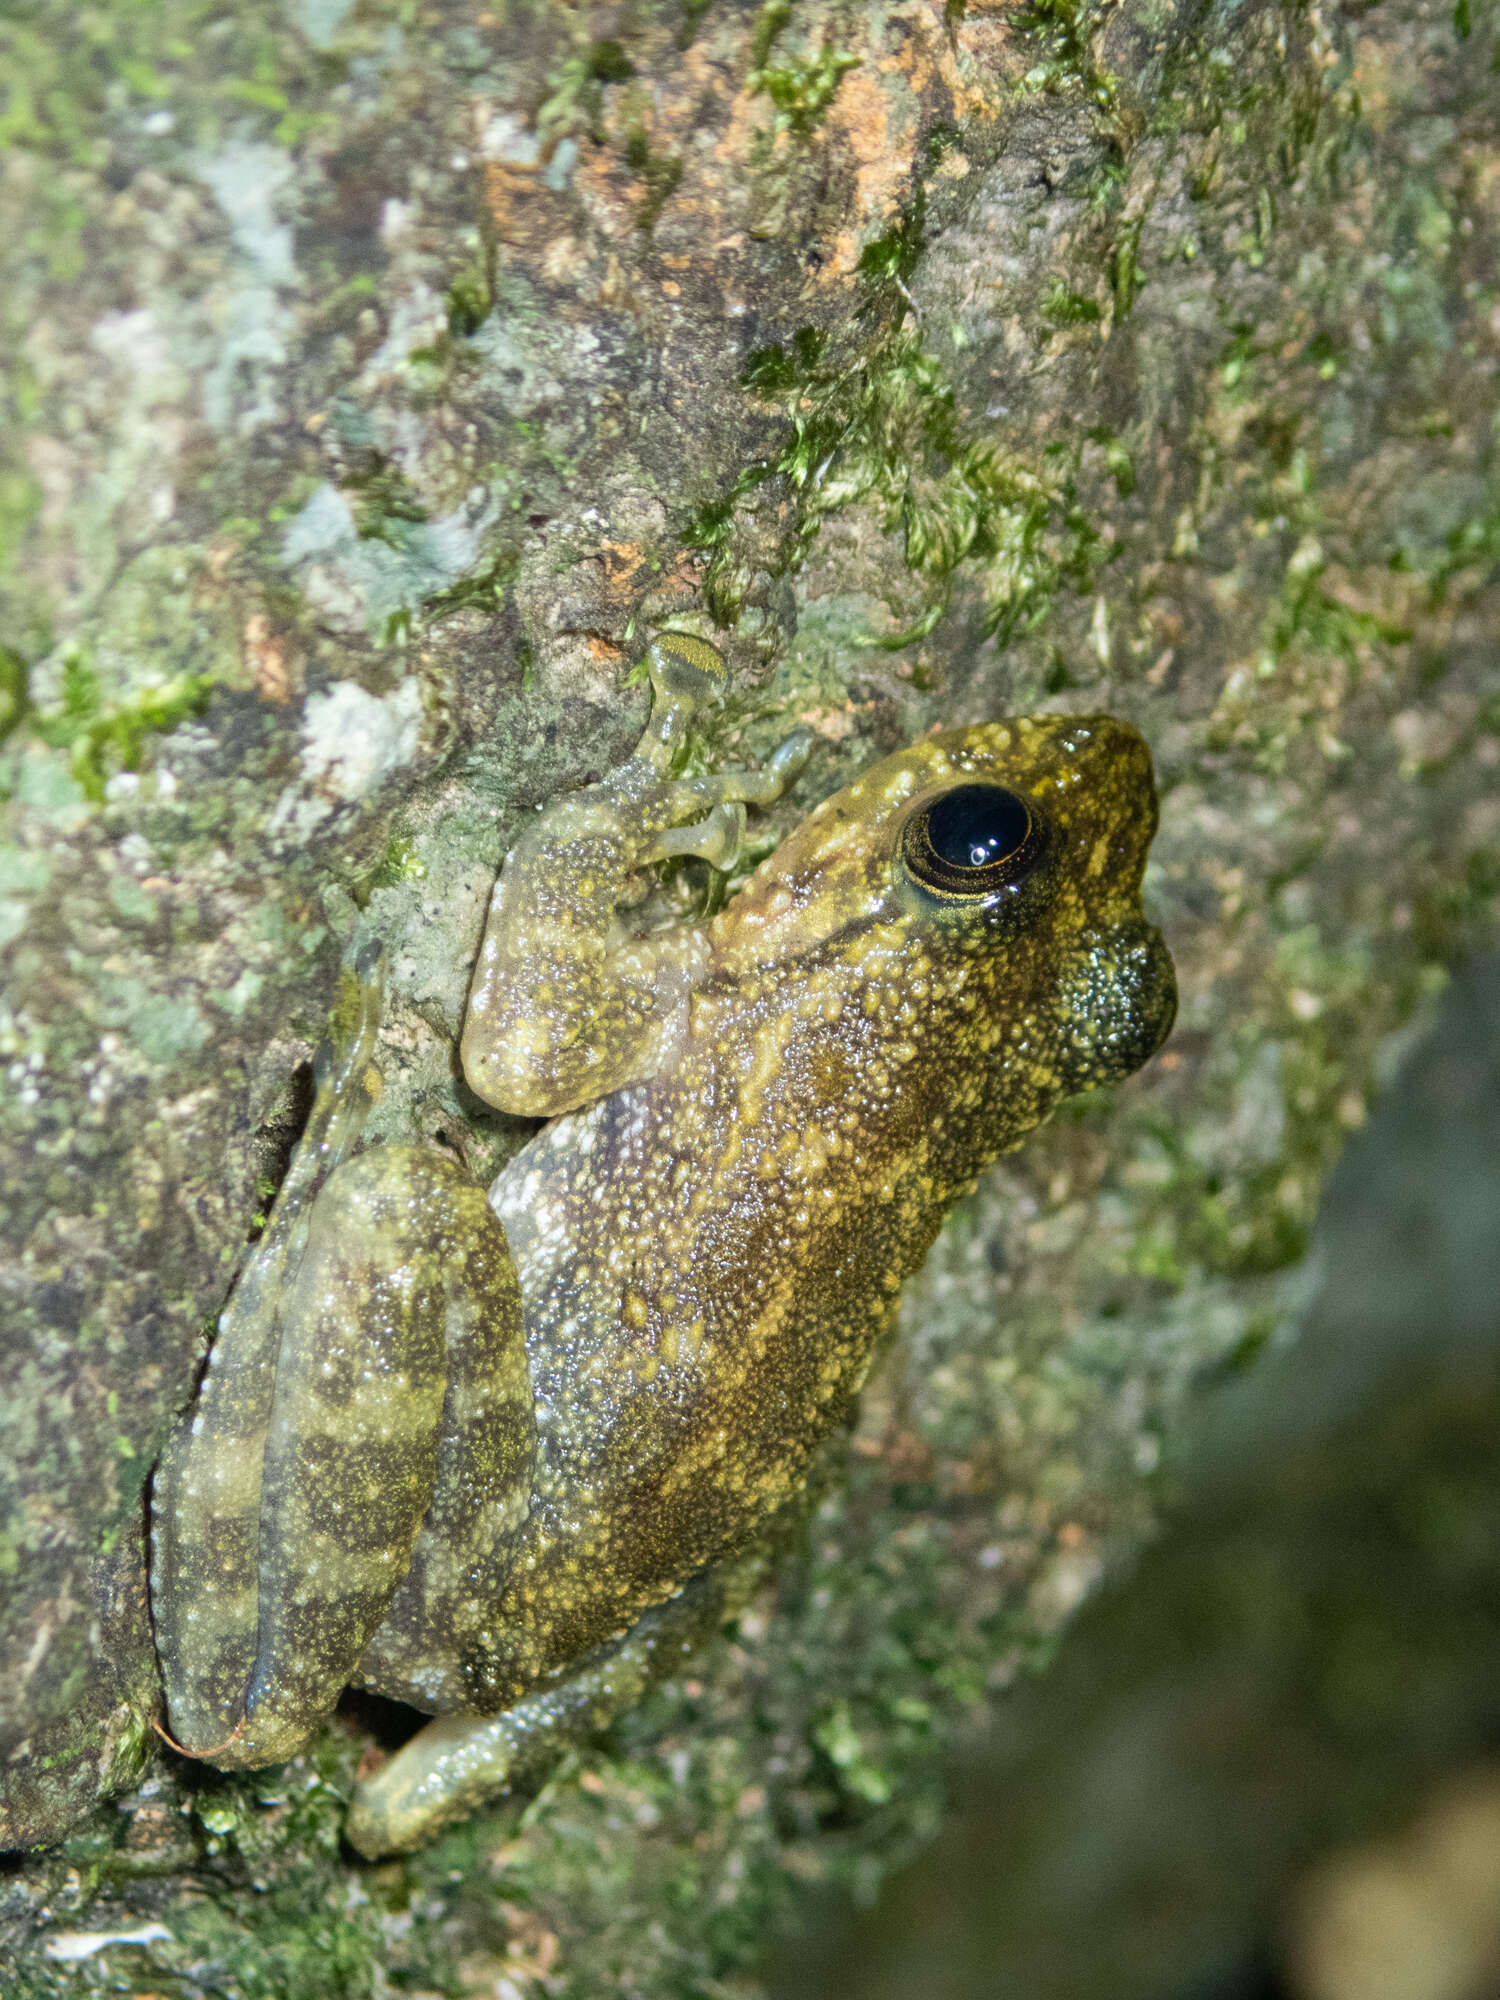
top-left (772, 958), bottom-right (1500, 2000)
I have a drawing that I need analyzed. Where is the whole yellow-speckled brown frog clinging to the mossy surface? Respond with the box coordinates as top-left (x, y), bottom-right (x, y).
top-left (150, 632), bottom-right (1176, 1856)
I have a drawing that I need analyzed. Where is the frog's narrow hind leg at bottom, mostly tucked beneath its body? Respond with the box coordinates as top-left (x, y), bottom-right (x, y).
top-left (344, 1550), bottom-right (764, 1860)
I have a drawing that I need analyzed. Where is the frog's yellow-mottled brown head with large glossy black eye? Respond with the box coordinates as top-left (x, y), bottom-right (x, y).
top-left (714, 714), bottom-right (1176, 1106)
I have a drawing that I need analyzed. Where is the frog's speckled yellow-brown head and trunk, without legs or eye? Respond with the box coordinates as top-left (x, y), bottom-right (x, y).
top-left (472, 718), bottom-right (1172, 1708)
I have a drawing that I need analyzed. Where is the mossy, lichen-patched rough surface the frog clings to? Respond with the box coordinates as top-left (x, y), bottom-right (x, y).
top-left (0, 0), bottom-right (1500, 1996)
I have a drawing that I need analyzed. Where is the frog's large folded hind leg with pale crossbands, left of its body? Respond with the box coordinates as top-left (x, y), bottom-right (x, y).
top-left (154, 1146), bottom-right (530, 1766)
